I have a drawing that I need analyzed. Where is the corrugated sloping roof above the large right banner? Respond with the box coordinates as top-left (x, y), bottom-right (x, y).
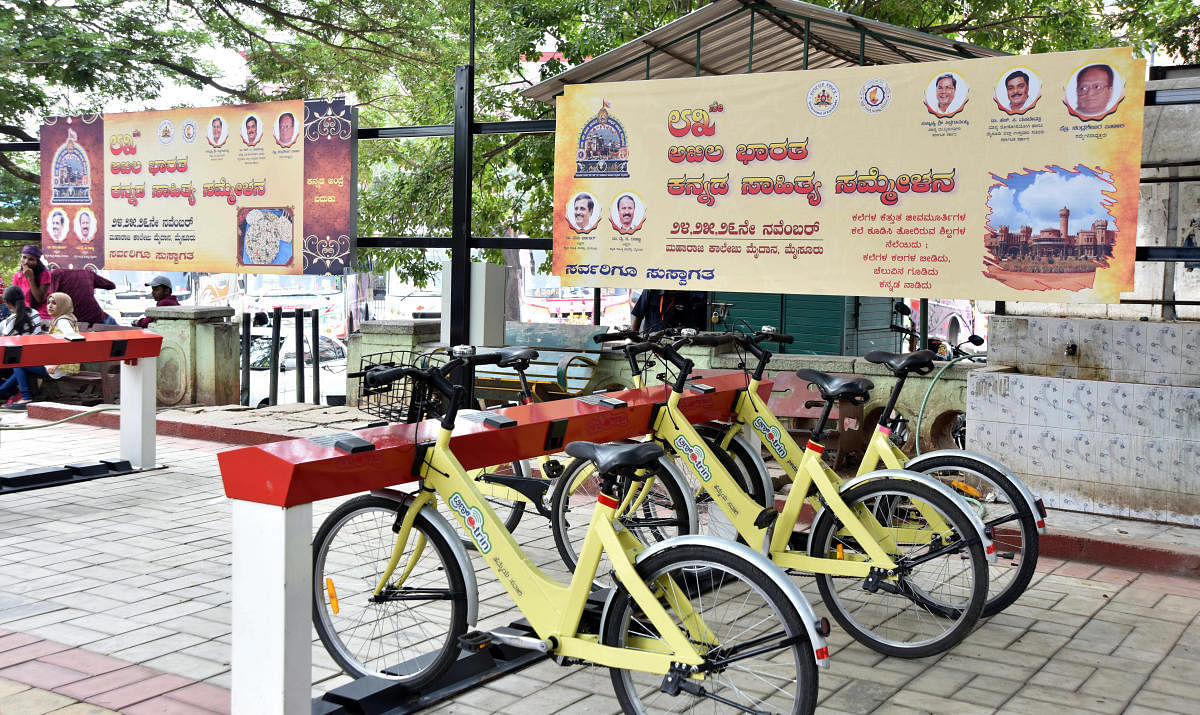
top-left (521, 0), bottom-right (1007, 102)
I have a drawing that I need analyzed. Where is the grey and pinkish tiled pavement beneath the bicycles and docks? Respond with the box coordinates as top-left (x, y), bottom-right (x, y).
top-left (0, 416), bottom-right (1200, 715)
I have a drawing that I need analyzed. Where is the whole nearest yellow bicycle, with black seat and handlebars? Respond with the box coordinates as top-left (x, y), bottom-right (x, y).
top-left (313, 354), bottom-right (828, 713)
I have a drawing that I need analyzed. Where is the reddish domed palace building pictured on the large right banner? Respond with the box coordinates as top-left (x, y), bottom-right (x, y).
top-left (984, 206), bottom-right (1117, 271)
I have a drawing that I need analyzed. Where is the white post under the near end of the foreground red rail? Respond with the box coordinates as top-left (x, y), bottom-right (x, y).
top-left (232, 499), bottom-right (312, 715)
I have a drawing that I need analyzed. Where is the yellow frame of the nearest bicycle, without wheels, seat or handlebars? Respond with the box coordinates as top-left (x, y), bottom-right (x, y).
top-left (377, 427), bottom-right (716, 674)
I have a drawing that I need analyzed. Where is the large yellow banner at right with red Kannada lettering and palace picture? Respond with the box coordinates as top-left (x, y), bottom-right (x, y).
top-left (553, 49), bottom-right (1146, 302)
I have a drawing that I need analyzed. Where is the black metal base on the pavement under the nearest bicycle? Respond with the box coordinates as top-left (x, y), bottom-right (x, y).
top-left (312, 619), bottom-right (548, 715)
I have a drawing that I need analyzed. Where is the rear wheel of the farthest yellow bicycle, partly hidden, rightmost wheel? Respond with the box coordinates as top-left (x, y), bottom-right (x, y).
top-left (905, 455), bottom-right (1040, 618)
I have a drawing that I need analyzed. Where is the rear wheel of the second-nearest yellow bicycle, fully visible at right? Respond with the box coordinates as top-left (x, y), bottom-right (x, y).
top-left (812, 479), bottom-right (988, 657)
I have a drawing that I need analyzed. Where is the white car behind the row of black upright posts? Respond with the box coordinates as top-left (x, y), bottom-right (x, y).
top-left (239, 328), bottom-right (346, 407)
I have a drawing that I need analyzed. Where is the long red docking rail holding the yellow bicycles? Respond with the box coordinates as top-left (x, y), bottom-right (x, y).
top-left (217, 371), bottom-right (770, 506)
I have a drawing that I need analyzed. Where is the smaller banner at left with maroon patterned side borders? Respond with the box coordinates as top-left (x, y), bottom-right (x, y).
top-left (41, 100), bottom-right (356, 274)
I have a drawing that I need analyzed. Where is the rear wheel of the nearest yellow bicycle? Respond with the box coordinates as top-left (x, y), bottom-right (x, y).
top-left (600, 545), bottom-right (817, 715)
